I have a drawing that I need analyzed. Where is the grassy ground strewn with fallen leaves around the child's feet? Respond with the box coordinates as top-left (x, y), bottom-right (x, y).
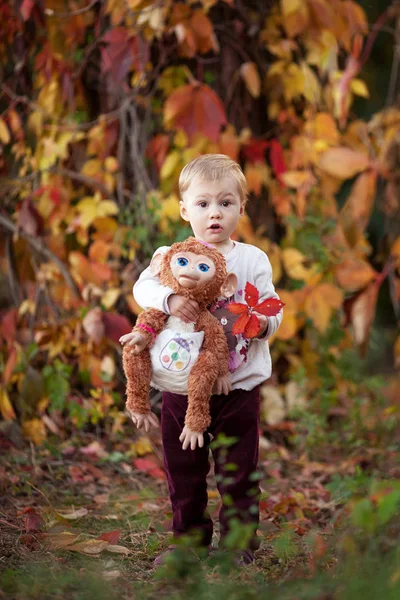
top-left (0, 372), bottom-right (400, 600)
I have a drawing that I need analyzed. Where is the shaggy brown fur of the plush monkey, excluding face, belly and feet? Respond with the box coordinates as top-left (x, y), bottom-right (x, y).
top-left (123, 238), bottom-right (233, 432)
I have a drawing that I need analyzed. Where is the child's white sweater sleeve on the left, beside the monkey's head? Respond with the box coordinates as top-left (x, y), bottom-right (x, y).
top-left (133, 246), bottom-right (174, 315)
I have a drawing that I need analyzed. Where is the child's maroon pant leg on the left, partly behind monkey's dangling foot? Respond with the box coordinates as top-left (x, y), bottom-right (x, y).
top-left (161, 392), bottom-right (213, 545)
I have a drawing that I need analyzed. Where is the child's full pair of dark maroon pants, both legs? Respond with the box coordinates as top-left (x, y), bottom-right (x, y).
top-left (161, 386), bottom-right (260, 547)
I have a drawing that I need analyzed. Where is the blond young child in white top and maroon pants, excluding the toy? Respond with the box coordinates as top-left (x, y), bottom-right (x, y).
top-left (120, 154), bottom-right (282, 565)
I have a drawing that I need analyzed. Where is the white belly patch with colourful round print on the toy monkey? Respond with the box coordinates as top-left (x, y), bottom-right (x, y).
top-left (150, 328), bottom-right (204, 394)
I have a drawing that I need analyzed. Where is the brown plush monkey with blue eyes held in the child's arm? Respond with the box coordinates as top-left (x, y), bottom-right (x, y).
top-left (123, 237), bottom-right (237, 449)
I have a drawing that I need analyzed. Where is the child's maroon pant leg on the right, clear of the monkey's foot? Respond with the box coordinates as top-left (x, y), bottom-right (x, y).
top-left (209, 386), bottom-right (260, 549)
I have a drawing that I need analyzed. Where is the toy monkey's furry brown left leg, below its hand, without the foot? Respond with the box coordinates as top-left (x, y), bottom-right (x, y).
top-left (123, 347), bottom-right (152, 414)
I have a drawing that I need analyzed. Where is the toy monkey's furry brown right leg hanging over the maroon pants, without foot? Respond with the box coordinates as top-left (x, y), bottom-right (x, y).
top-left (185, 350), bottom-right (219, 432)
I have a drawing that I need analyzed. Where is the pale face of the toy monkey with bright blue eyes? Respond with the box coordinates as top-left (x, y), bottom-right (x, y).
top-left (170, 252), bottom-right (215, 290)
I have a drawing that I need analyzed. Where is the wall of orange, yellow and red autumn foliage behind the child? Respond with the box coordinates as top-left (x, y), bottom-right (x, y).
top-left (0, 0), bottom-right (400, 454)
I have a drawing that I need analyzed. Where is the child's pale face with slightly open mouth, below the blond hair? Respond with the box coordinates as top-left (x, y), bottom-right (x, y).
top-left (181, 176), bottom-right (244, 246)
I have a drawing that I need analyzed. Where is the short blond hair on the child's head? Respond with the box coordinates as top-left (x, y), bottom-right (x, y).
top-left (179, 154), bottom-right (248, 205)
